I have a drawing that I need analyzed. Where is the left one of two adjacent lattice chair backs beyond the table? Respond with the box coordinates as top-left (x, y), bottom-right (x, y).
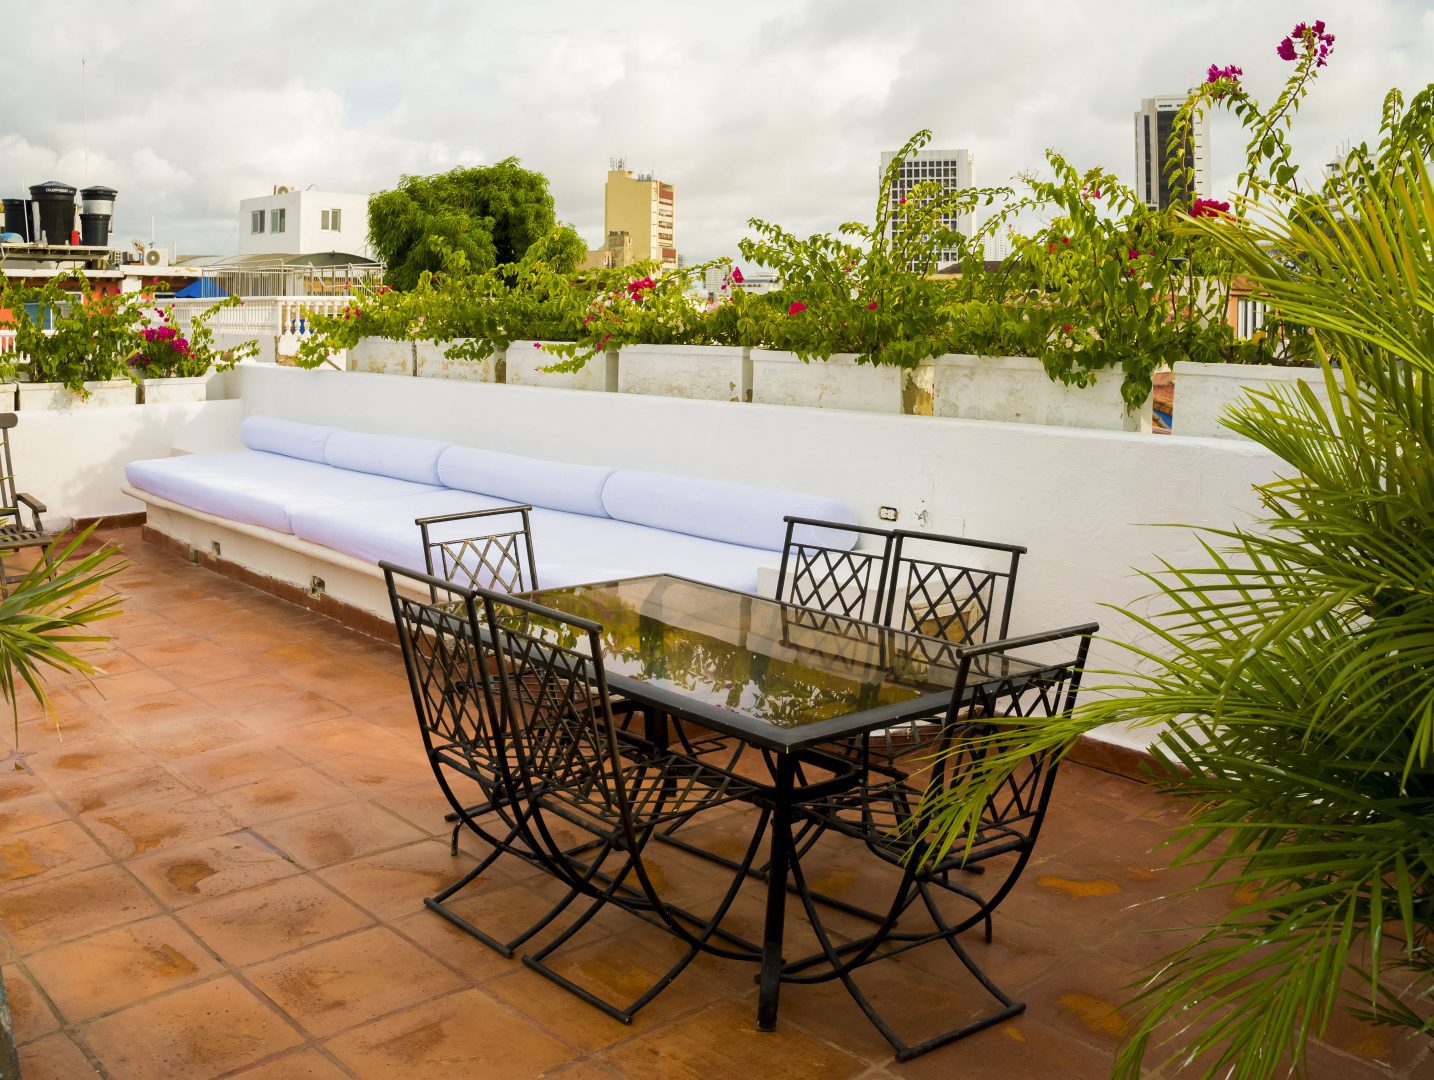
top-left (777, 516), bottom-right (892, 621)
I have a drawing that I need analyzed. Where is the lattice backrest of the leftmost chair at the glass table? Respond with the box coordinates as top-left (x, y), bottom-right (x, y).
top-left (380, 562), bottom-right (500, 783)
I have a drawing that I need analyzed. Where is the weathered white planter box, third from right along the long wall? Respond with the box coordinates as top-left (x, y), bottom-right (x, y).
top-left (751, 349), bottom-right (935, 416)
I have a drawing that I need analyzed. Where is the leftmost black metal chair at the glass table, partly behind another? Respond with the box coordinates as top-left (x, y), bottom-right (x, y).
top-left (380, 562), bottom-right (578, 957)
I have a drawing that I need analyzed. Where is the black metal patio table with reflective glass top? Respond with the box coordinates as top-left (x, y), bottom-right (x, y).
top-left (526, 574), bottom-right (1035, 1031)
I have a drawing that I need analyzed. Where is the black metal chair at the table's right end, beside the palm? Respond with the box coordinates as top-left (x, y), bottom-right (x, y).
top-left (783, 624), bottom-right (1097, 1061)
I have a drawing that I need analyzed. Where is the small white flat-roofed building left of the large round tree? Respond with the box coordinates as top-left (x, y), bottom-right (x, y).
top-left (239, 185), bottom-right (371, 258)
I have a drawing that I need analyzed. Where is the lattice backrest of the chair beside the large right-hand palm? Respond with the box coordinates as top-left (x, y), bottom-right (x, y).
top-left (928, 622), bottom-right (1098, 854)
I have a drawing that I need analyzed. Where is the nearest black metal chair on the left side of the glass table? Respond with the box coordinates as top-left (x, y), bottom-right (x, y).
top-left (479, 589), bottom-right (767, 1023)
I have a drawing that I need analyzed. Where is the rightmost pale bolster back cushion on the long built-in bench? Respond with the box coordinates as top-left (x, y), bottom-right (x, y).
top-left (602, 469), bottom-right (856, 551)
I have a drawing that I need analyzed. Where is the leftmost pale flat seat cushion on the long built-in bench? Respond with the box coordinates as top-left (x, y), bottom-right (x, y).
top-left (125, 450), bottom-right (436, 532)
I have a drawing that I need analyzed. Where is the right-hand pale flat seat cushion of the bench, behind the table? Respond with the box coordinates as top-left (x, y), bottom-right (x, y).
top-left (293, 491), bottom-right (773, 592)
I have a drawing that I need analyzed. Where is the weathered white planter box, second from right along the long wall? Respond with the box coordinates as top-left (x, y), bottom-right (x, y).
top-left (934, 356), bottom-right (1152, 433)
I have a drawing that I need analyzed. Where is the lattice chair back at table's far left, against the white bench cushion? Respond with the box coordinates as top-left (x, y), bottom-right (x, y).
top-left (414, 506), bottom-right (538, 592)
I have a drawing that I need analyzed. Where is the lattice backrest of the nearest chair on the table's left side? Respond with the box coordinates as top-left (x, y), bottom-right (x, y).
top-left (480, 589), bottom-right (631, 843)
